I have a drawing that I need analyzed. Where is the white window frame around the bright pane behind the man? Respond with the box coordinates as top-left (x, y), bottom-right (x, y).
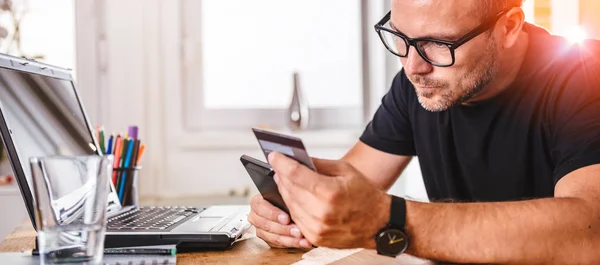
top-left (180, 0), bottom-right (385, 131)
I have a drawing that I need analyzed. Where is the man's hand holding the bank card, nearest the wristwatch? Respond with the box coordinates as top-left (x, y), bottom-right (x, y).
top-left (269, 152), bottom-right (391, 248)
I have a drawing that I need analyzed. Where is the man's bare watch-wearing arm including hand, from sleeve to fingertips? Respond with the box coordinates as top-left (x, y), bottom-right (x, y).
top-left (269, 152), bottom-right (600, 264)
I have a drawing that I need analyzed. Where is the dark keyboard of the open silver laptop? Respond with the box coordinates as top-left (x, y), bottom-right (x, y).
top-left (108, 207), bottom-right (204, 232)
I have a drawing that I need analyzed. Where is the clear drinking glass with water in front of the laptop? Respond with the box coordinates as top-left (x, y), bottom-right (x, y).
top-left (30, 156), bottom-right (113, 264)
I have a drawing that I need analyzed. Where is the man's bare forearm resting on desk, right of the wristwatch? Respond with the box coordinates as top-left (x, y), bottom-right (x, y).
top-left (406, 198), bottom-right (600, 264)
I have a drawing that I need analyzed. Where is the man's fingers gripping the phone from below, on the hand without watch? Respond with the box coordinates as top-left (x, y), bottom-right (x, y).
top-left (248, 194), bottom-right (311, 248)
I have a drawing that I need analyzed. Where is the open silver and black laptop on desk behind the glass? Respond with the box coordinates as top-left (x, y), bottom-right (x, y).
top-left (0, 54), bottom-right (250, 250)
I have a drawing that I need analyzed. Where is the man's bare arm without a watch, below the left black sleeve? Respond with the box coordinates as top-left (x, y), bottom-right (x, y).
top-left (341, 141), bottom-right (412, 191)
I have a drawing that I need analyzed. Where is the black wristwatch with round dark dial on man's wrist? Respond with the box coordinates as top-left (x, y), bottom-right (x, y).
top-left (375, 195), bottom-right (408, 257)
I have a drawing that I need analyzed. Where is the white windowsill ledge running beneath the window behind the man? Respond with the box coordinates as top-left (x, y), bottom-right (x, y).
top-left (172, 128), bottom-right (363, 150)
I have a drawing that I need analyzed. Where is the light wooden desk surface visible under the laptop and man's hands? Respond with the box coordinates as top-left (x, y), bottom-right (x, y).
top-left (0, 219), bottom-right (432, 265)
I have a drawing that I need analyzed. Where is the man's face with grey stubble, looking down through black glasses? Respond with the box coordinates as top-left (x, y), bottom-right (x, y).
top-left (390, 0), bottom-right (499, 111)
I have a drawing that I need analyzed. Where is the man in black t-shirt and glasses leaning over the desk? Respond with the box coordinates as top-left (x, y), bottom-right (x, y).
top-left (249, 0), bottom-right (600, 264)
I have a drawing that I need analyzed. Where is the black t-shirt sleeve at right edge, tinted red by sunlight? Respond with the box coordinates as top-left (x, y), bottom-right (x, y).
top-left (550, 58), bottom-right (600, 183)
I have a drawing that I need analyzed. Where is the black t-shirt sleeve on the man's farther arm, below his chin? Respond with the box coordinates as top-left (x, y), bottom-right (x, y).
top-left (360, 72), bottom-right (416, 156)
